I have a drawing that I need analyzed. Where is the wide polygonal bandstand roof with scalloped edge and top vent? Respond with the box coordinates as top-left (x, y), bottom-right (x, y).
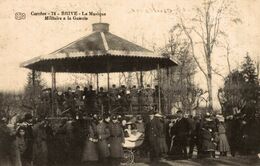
top-left (21, 23), bottom-right (177, 73)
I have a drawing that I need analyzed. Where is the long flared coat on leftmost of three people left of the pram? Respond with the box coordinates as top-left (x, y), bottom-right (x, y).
top-left (82, 122), bottom-right (98, 161)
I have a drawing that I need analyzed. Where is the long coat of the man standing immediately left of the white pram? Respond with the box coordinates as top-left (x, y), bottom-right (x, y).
top-left (109, 123), bottom-right (124, 158)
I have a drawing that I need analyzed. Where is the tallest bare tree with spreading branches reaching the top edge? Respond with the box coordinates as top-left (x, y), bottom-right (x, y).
top-left (178, 0), bottom-right (240, 111)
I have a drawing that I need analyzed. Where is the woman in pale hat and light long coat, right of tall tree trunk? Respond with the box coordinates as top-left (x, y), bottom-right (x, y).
top-left (217, 115), bottom-right (230, 156)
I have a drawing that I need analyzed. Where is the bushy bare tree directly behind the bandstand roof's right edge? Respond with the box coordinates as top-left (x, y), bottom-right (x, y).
top-left (159, 26), bottom-right (206, 113)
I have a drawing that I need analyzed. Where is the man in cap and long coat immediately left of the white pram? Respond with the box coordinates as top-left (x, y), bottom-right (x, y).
top-left (109, 115), bottom-right (125, 165)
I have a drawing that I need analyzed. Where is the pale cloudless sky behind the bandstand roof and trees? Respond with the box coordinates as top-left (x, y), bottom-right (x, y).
top-left (0, 0), bottom-right (260, 109)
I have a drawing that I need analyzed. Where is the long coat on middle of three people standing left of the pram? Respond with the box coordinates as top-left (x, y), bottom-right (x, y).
top-left (97, 122), bottom-right (110, 158)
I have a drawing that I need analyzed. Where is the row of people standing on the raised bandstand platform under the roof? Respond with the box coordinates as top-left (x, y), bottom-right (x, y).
top-left (37, 84), bottom-right (164, 116)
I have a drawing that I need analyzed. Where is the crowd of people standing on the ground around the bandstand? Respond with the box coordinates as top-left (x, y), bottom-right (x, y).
top-left (0, 102), bottom-right (260, 166)
